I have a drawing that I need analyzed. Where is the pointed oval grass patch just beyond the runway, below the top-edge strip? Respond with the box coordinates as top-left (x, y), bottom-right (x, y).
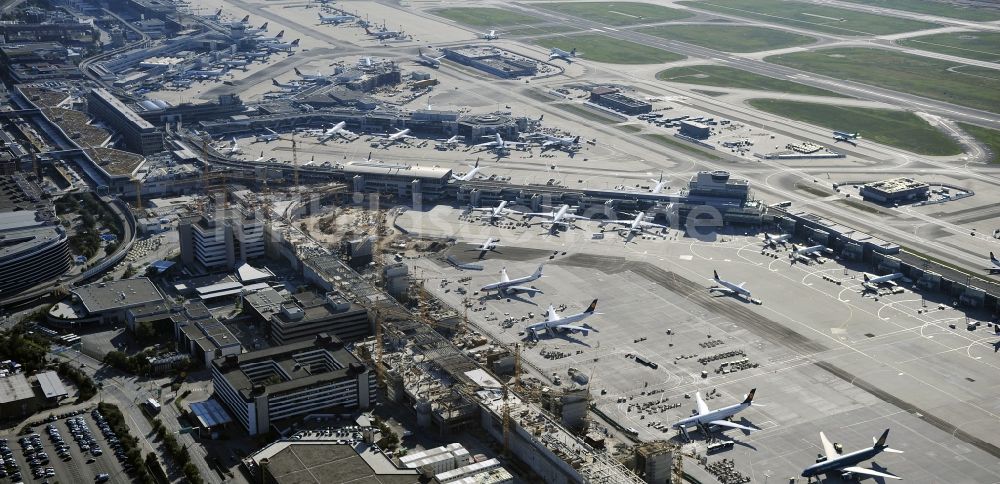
top-left (639, 25), bottom-right (816, 52)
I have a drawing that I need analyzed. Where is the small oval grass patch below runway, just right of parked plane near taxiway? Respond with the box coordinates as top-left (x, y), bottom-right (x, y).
top-left (534, 34), bottom-right (685, 64)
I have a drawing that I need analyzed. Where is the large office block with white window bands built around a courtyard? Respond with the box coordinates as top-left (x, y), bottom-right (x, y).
top-left (212, 334), bottom-right (377, 435)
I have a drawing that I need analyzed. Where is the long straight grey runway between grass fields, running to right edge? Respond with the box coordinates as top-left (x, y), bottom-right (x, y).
top-left (504, 3), bottom-right (1000, 129)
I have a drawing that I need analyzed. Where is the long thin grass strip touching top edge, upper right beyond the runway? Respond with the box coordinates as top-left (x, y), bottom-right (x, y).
top-left (678, 0), bottom-right (938, 35)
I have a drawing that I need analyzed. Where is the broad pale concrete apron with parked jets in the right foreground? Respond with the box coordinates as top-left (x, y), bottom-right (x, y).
top-left (398, 207), bottom-right (1000, 482)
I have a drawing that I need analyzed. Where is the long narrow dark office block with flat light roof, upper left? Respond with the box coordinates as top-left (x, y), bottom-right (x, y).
top-left (87, 88), bottom-right (163, 155)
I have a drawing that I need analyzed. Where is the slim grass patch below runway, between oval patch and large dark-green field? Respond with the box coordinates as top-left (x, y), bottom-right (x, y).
top-left (656, 65), bottom-right (844, 97)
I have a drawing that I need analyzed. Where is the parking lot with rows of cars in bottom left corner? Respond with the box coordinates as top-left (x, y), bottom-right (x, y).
top-left (0, 410), bottom-right (132, 483)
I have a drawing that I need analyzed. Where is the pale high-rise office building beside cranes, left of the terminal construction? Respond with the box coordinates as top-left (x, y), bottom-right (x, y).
top-left (177, 209), bottom-right (264, 272)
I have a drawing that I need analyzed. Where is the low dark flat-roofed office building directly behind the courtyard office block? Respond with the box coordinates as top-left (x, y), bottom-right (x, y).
top-left (271, 291), bottom-right (372, 345)
